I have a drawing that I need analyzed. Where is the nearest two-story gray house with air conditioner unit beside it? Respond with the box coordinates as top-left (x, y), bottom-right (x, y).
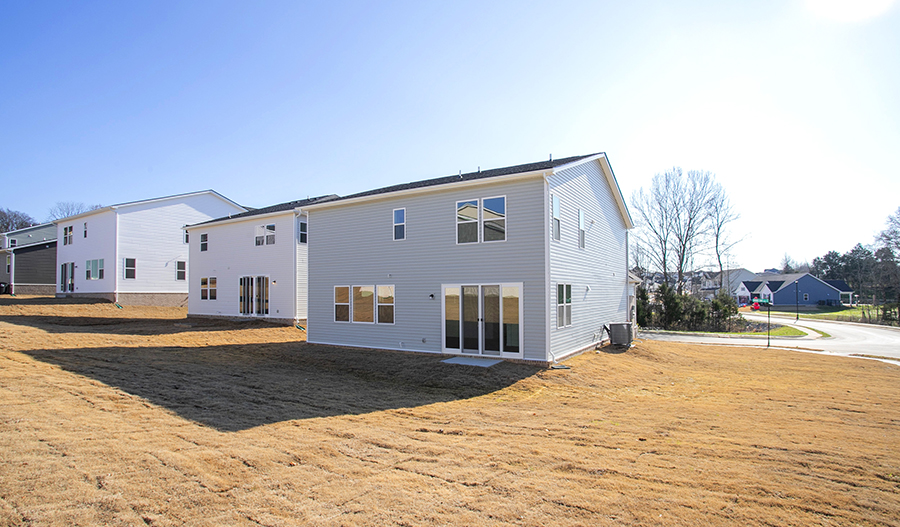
top-left (304, 153), bottom-right (633, 363)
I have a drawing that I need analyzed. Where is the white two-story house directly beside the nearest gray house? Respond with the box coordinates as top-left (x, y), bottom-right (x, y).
top-left (185, 195), bottom-right (337, 324)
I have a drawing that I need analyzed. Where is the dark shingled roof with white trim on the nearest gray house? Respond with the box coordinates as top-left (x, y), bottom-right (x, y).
top-left (307, 152), bottom-right (634, 229)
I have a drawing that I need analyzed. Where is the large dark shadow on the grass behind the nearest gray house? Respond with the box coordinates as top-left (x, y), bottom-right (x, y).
top-left (21, 343), bottom-right (541, 432)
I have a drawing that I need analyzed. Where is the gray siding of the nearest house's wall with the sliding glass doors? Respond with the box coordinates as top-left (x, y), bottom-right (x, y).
top-left (308, 178), bottom-right (550, 360)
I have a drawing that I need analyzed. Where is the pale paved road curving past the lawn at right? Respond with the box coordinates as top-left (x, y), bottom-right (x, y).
top-left (641, 314), bottom-right (900, 362)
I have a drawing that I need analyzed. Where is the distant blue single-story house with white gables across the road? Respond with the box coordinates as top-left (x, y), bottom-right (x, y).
top-left (734, 273), bottom-right (853, 306)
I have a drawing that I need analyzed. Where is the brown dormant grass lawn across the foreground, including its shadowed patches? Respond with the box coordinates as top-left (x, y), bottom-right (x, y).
top-left (0, 297), bottom-right (900, 526)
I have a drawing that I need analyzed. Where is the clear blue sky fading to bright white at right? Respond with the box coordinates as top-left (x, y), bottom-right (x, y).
top-left (0, 0), bottom-right (900, 271)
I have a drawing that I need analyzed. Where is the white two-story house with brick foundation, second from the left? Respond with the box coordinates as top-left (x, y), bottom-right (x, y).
top-left (54, 190), bottom-right (247, 306)
